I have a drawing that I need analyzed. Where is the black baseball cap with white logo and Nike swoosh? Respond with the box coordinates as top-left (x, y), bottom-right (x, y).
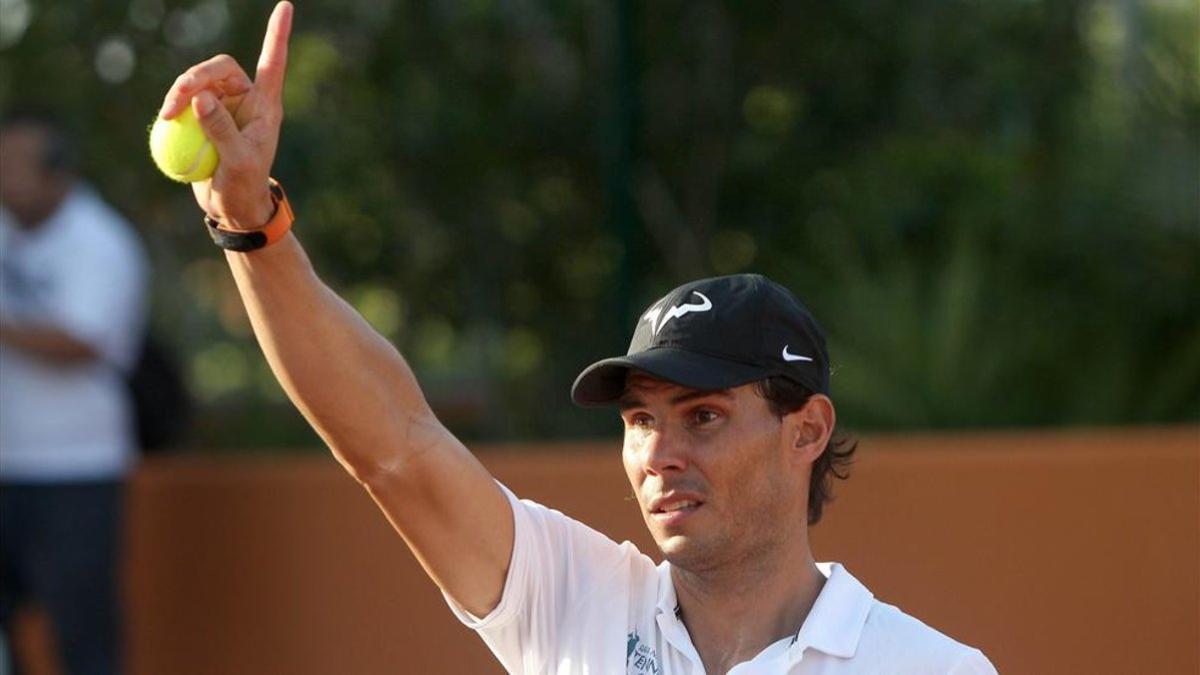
top-left (571, 274), bottom-right (829, 407)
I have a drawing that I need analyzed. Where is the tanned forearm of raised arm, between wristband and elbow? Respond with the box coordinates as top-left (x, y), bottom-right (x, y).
top-left (227, 230), bottom-right (440, 482)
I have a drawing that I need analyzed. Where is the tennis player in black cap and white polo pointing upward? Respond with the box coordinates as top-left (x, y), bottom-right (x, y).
top-left (161, 2), bottom-right (995, 675)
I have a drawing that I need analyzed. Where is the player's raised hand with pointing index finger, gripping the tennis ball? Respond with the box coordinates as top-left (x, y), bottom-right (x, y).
top-left (158, 0), bottom-right (293, 229)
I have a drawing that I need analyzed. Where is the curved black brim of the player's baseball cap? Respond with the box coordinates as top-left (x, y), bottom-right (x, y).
top-left (571, 347), bottom-right (770, 407)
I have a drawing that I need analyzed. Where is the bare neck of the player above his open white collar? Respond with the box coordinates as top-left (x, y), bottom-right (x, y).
top-left (671, 532), bottom-right (826, 673)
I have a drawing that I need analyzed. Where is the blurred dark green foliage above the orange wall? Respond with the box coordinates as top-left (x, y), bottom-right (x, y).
top-left (0, 0), bottom-right (1200, 446)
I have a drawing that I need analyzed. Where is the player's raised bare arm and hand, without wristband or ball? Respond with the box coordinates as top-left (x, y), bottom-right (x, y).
top-left (158, 1), bottom-right (514, 615)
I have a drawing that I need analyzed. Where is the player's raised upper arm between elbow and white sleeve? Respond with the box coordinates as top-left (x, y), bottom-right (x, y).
top-left (364, 416), bottom-right (514, 616)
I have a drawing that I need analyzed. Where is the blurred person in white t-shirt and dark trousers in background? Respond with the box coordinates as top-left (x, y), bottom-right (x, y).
top-left (0, 112), bottom-right (146, 674)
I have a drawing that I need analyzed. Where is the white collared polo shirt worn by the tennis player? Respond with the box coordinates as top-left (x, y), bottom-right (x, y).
top-left (446, 488), bottom-right (996, 675)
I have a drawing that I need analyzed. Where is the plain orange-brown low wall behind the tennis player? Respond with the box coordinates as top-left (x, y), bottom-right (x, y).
top-left (16, 428), bottom-right (1200, 675)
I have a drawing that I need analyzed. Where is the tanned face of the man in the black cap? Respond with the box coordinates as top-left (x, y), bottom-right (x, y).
top-left (620, 372), bottom-right (808, 573)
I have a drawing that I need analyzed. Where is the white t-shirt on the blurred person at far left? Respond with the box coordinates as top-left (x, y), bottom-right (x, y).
top-left (0, 185), bottom-right (146, 482)
